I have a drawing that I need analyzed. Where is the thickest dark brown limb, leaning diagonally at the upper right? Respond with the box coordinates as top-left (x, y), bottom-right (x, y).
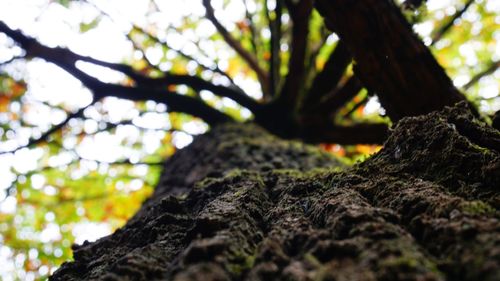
top-left (315, 0), bottom-right (465, 120)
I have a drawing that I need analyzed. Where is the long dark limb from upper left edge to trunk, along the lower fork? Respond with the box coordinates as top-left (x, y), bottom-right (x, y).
top-left (0, 22), bottom-right (231, 125)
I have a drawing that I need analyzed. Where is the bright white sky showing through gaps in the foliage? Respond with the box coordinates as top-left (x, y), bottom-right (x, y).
top-left (0, 0), bottom-right (500, 280)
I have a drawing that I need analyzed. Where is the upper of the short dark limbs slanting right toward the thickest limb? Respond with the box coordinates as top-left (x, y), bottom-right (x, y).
top-left (304, 41), bottom-right (352, 107)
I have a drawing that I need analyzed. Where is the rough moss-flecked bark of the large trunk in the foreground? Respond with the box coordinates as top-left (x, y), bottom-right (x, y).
top-left (51, 103), bottom-right (500, 281)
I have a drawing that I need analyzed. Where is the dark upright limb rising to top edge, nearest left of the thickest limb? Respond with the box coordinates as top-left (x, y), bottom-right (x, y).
top-left (278, 0), bottom-right (313, 111)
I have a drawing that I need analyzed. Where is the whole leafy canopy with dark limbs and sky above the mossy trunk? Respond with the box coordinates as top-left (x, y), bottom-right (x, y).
top-left (0, 0), bottom-right (500, 279)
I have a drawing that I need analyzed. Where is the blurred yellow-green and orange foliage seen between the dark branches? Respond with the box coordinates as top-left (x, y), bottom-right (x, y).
top-left (0, 0), bottom-right (500, 280)
